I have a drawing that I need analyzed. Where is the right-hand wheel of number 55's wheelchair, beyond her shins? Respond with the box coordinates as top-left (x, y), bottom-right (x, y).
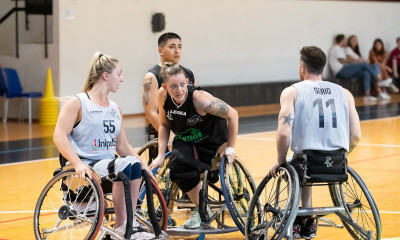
top-left (137, 175), bottom-right (168, 231)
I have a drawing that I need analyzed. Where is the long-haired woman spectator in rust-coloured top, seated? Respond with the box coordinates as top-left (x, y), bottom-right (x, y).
top-left (369, 38), bottom-right (392, 99)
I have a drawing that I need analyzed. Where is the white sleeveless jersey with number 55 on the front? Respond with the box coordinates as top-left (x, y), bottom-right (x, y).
top-left (68, 93), bottom-right (121, 160)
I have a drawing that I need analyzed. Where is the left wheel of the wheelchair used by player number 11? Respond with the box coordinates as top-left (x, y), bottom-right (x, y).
top-left (245, 164), bottom-right (300, 240)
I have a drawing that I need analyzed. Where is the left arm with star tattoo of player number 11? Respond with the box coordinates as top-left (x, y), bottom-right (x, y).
top-left (269, 86), bottom-right (297, 177)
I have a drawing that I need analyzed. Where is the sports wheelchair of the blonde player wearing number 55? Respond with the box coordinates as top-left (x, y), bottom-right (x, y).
top-left (33, 155), bottom-right (168, 239)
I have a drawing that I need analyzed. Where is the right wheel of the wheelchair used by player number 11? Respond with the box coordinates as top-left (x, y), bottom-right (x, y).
top-left (329, 167), bottom-right (382, 240)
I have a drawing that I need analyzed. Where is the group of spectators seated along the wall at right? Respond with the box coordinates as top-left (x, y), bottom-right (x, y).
top-left (328, 34), bottom-right (400, 101)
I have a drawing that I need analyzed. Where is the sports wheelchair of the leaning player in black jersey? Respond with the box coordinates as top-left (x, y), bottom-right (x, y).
top-left (138, 139), bottom-right (256, 239)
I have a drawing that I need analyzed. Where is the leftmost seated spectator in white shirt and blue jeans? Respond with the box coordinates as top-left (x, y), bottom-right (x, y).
top-left (329, 34), bottom-right (388, 101)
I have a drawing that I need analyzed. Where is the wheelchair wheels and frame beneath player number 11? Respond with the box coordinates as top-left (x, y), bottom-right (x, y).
top-left (245, 158), bottom-right (382, 240)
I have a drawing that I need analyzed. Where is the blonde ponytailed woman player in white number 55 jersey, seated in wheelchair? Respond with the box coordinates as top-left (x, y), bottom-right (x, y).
top-left (53, 53), bottom-right (154, 239)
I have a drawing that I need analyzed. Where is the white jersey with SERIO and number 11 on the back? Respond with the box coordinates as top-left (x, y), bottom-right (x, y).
top-left (291, 80), bottom-right (350, 154)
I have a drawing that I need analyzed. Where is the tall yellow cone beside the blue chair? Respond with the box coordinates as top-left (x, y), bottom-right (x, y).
top-left (40, 68), bottom-right (59, 126)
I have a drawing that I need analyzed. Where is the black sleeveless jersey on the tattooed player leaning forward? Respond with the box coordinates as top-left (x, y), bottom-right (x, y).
top-left (164, 86), bottom-right (228, 146)
